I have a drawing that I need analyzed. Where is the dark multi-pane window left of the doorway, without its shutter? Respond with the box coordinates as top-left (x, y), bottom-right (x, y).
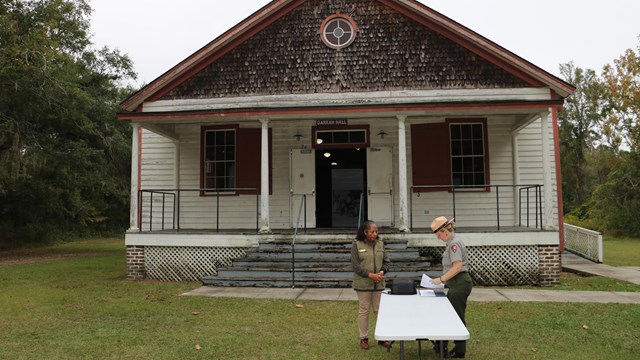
top-left (204, 130), bottom-right (236, 190)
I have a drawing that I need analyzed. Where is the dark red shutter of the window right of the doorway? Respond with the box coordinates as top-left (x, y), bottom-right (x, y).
top-left (411, 123), bottom-right (451, 192)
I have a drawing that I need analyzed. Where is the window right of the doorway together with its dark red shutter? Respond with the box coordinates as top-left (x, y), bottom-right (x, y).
top-left (411, 119), bottom-right (489, 192)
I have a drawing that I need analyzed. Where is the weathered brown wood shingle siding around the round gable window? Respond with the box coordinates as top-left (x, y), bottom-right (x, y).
top-left (161, 0), bottom-right (531, 100)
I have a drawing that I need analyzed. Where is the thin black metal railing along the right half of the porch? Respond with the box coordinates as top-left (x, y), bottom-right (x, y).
top-left (409, 184), bottom-right (543, 230)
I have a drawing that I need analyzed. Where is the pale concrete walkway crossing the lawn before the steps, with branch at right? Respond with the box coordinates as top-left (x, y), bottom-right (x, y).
top-left (183, 252), bottom-right (640, 304)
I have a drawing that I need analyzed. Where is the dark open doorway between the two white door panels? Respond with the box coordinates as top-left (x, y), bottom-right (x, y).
top-left (316, 149), bottom-right (367, 228)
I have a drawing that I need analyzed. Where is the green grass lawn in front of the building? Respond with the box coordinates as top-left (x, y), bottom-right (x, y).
top-left (0, 239), bottom-right (640, 360)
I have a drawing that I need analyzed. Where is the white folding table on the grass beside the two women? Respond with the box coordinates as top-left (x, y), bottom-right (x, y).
top-left (375, 293), bottom-right (469, 360)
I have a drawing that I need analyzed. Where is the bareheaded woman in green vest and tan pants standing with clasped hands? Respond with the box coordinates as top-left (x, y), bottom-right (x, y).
top-left (351, 220), bottom-right (389, 350)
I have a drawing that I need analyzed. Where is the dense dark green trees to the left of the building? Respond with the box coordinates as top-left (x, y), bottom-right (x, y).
top-left (0, 0), bottom-right (135, 246)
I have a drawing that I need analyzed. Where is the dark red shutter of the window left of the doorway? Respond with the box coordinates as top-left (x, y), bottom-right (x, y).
top-left (236, 128), bottom-right (271, 194)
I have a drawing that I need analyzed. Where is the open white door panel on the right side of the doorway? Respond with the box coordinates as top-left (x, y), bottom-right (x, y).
top-left (367, 147), bottom-right (394, 227)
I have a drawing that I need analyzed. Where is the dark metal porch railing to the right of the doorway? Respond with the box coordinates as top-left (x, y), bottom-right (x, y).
top-left (409, 184), bottom-right (544, 230)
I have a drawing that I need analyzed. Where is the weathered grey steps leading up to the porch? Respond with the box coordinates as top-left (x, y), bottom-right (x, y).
top-left (202, 240), bottom-right (440, 288)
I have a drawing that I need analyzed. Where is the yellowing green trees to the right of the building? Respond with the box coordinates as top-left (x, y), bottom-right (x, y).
top-left (560, 39), bottom-right (640, 236)
